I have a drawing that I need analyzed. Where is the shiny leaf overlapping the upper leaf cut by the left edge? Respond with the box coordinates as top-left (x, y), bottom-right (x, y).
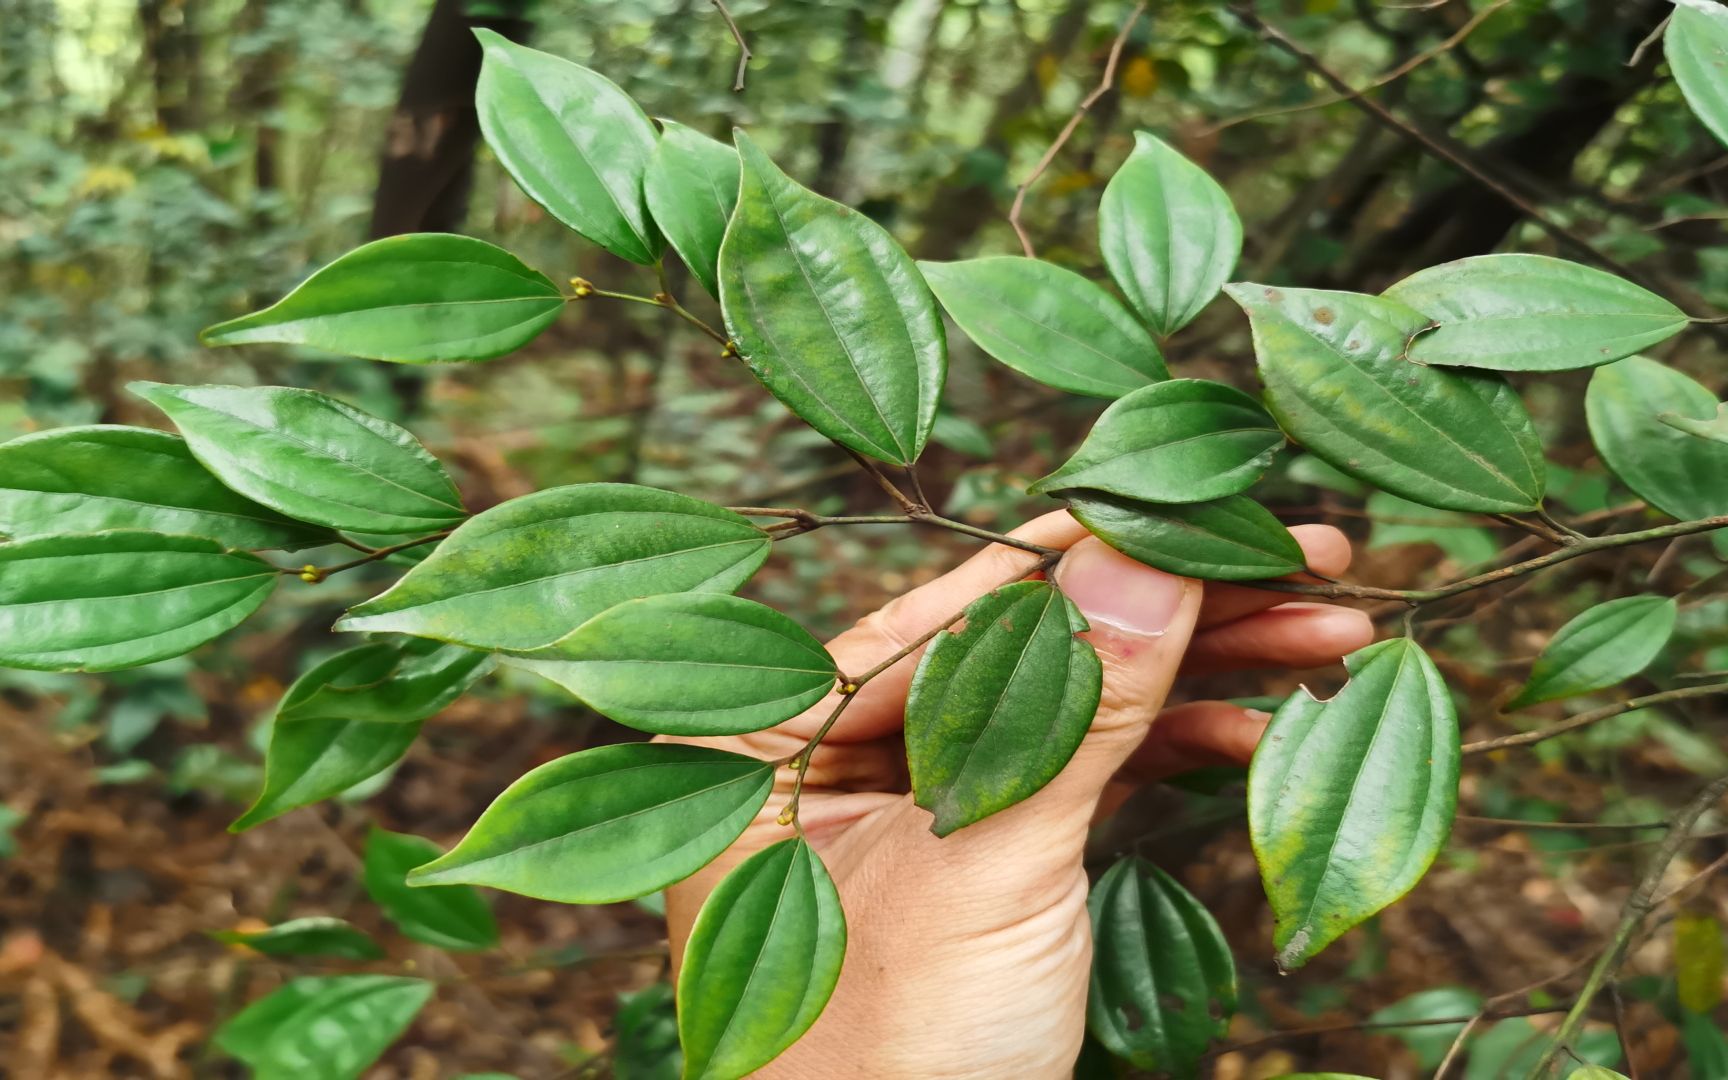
top-left (126, 382), bottom-right (465, 532)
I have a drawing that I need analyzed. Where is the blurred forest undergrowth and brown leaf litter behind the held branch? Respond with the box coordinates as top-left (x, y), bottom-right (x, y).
top-left (0, 0), bottom-right (1728, 1080)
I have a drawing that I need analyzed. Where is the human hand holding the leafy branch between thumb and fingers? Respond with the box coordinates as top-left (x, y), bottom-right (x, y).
top-left (665, 511), bottom-right (1374, 1080)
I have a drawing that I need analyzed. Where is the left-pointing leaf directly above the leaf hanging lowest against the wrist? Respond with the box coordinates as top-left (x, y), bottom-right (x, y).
top-left (411, 743), bottom-right (774, 898)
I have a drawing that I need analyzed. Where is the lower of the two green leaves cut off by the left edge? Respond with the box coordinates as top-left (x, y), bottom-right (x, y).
top-left (0, 530), bottom-right (282, 670)
